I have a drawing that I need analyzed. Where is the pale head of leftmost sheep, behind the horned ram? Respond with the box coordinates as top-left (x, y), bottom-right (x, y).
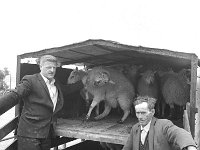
top-left (67, 68), bottom-right (86, 84)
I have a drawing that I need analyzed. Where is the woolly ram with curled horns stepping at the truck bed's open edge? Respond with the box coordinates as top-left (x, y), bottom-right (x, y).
top-left (68, 67), bottom-right (135, 123)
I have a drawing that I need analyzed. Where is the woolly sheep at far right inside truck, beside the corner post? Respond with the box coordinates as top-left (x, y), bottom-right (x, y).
top-left (159, 69), bottom-right (190, 119)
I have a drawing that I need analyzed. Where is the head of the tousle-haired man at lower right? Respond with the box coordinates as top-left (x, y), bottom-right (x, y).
top-left (134, 96), bottom-right (156, 127)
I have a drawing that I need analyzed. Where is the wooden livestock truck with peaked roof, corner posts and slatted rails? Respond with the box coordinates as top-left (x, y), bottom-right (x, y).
top-left (0, 39), bottom-right (200, 150)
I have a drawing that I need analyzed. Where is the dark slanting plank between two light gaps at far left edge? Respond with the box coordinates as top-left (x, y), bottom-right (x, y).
top-left (0, 117), bottom-right (18, 139)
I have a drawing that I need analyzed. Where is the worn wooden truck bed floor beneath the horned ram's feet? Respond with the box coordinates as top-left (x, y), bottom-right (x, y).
top-left (56, 116), bottom-right (137, 145)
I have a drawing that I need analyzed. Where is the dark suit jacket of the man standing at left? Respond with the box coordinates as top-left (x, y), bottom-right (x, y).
top-left (6, 74), bottom-right (83, 138)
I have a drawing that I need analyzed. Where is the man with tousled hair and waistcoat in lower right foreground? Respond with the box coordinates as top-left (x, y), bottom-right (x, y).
top-left (123, 96), bottom-right (197, 150)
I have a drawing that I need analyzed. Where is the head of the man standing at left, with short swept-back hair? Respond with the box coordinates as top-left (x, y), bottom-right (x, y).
top-left (40, 55), bottom-right (58, 80)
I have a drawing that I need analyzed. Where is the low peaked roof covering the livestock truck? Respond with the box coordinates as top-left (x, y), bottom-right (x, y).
top-left (19, 39), bottom-right (200, 68)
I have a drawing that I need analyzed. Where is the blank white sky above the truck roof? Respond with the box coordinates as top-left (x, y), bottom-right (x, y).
top-left (0, 0), bottom-right (200, 73)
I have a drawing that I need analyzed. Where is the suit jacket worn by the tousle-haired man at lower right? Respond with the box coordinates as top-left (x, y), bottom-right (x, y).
top-left (123, 117), bottom-right (196, 150)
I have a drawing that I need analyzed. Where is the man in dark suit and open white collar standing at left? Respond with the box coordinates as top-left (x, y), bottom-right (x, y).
top-left (0, 55), bottom-right (84, 150)
